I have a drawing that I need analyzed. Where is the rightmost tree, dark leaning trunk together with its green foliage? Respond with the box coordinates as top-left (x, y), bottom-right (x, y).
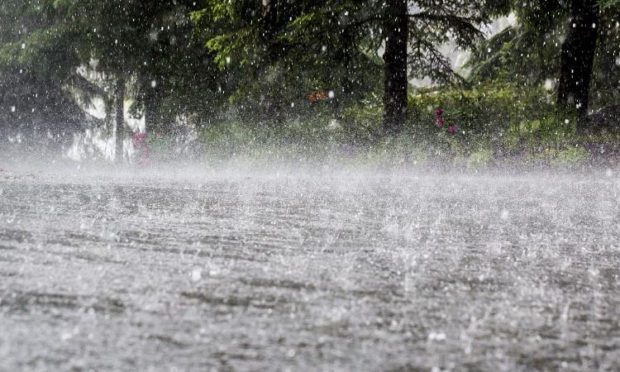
top-left (471, 0), bottom-right (620, 131)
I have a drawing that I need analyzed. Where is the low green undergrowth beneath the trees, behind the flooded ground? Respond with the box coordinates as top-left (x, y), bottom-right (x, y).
top-left (195, 78), bottom-right (600, 169)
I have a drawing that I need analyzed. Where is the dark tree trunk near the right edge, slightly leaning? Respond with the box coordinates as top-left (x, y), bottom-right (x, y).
top-left (558, 0), bottom-right (600, 131)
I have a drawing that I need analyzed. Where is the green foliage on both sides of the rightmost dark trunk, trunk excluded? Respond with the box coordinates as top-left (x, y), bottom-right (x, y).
top-left (468, 0), bottom-right (620, 109)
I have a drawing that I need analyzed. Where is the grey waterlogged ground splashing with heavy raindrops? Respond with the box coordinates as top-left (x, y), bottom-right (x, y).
top-left (0, 171), bottom-right (620, 371)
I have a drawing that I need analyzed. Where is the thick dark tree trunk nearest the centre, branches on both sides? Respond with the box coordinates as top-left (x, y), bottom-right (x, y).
top-left (383, 0), bottom-right (408, 135)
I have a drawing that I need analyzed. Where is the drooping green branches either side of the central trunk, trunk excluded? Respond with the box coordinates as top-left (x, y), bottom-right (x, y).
top-left (191, 0), bottom-right (490, 132)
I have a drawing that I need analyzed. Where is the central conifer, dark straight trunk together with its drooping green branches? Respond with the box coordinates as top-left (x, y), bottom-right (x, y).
top-left (193, 0), bottom-right (487, 134)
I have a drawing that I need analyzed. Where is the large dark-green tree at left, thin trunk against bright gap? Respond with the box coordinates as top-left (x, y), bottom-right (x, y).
top-left (0, 0), bottom-right (218, 160)
